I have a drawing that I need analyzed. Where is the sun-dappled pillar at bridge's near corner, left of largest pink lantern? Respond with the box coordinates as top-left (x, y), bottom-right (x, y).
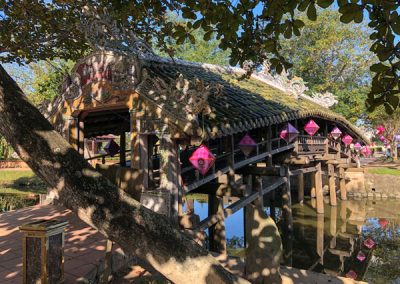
top-left (160, 134), bottom-right (180, 223)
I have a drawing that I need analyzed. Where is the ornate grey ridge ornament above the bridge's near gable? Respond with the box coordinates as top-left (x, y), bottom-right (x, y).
top-left (80, 5), bottom-right (159, 58)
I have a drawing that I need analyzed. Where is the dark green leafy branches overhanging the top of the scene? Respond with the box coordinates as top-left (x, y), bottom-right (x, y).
top-left (0, 0), bottom-right (400, 113)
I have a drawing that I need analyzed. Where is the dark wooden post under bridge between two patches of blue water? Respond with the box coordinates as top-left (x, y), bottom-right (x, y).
top-left (208, 194), bottom-right (227, 254)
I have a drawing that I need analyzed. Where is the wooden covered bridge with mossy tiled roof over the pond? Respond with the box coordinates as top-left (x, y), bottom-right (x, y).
top-left (44, 51), bottom-right (372, 280)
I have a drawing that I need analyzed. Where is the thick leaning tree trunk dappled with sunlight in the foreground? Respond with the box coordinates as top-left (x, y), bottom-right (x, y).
top-left (0, 66), bottom-right (247, 283)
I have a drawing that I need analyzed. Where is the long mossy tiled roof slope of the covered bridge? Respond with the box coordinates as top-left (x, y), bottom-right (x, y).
top-left (139, 60), bottom-right (368, 142)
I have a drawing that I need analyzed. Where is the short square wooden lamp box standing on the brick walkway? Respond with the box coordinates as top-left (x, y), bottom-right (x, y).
top-left (19, 220), bottom-right (67, 284)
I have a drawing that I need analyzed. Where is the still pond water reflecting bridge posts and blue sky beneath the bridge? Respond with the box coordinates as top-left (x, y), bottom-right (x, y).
top-left (187, 195), bottom-right (400, 283)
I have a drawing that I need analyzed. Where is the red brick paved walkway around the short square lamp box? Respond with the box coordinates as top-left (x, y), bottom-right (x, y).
top-left (0, 205), bottom-right (106, 284)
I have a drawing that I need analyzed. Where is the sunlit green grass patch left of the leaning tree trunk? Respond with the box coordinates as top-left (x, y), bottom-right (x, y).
top-left (0, 170), bottom-right (46, 194)
